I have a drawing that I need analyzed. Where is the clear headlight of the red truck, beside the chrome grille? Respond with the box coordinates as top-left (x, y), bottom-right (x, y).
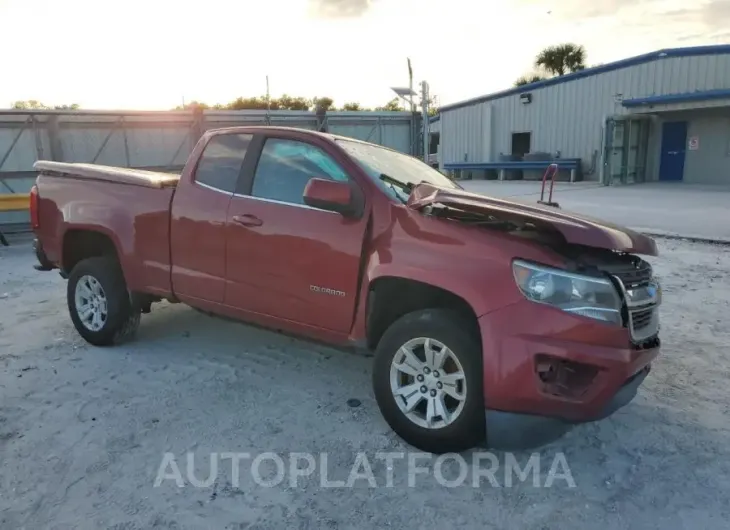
top-left (512, 260), bottom-right (622, 325)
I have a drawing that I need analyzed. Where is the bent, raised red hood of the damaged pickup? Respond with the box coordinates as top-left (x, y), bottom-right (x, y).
top-left (407, 183), bottom-right (657, 256)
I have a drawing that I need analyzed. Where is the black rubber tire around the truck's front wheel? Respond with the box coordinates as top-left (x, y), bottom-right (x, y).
top-left (373, 309), bottom-right (485, 453)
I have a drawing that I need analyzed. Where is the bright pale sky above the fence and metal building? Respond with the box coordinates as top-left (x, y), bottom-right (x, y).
top-left (0, 0), bottom-right (730, 110)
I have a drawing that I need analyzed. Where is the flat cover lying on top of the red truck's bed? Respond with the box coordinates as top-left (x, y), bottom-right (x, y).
top-left (33, 160), bottom-right (180, 189)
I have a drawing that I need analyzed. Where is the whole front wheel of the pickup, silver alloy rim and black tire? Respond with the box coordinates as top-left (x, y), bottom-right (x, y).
top-left (373, 309), bottom-right (485, 453)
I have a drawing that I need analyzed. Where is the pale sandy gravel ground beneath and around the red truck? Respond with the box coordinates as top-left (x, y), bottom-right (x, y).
top-left (0, 240), bottom-right (730, 530)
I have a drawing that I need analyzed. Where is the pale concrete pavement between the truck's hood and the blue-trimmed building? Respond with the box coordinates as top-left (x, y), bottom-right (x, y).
top-left (460, 180), bottom-right (730, 241)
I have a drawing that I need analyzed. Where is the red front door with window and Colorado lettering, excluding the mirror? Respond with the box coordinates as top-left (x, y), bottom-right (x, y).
top-left (225, 138), bottom-right (367, 332)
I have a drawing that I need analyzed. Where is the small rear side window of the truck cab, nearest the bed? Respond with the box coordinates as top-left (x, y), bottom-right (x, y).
top-left (195, 134), bottom-right (253, 193)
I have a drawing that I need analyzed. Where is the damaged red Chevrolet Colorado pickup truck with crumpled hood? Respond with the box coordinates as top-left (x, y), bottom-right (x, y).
top-left (31, 127), bottom-right (661, 452)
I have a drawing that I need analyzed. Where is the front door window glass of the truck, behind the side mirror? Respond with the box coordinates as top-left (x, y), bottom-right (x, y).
top-left (251, 138), bottom-right (349, 204)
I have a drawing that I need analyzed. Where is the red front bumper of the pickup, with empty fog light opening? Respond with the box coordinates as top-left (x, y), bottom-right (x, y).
top-left (479, 300), bottom-right (659, 449)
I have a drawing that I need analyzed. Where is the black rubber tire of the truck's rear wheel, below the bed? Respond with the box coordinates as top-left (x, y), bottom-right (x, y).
top-left (66, 256), bottom-right (141, 346)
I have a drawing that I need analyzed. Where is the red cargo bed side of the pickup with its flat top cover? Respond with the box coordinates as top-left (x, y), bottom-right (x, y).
top-left (34, 160), bottom-right (180, 296)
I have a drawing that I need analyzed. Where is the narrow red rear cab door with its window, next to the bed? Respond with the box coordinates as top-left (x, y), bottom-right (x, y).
top-left (170, 134), bottom-right (253, 303)
